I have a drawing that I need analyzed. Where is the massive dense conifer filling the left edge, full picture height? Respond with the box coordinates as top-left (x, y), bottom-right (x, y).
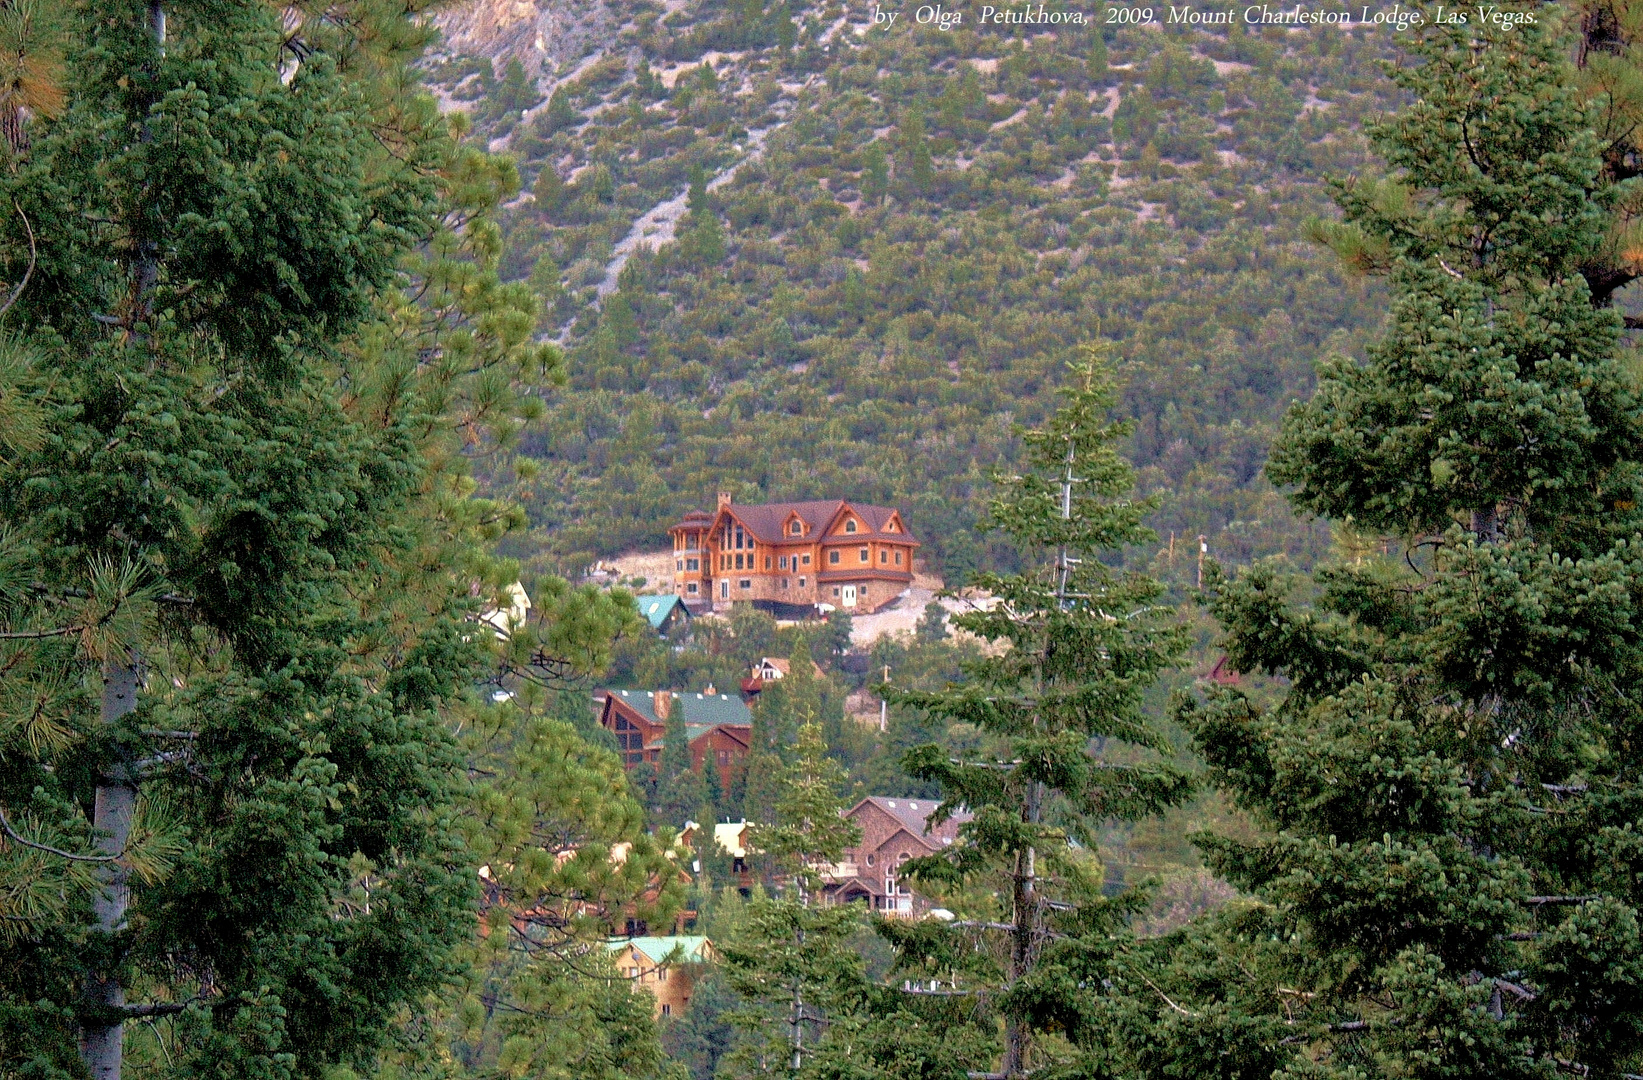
top-left (0, 0), bottom-right (552, 1077)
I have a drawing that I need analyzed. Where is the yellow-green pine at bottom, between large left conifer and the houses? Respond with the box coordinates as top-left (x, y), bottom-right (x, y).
top-left (433, 695), bottom-right (682, 1080)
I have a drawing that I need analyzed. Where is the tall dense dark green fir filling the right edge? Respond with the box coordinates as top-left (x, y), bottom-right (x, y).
top-left (1107, 14), bottom-right (1643, 1077)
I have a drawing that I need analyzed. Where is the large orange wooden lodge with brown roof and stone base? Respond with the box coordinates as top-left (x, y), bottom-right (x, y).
top-left (667, 492), bottom-right (918, 618)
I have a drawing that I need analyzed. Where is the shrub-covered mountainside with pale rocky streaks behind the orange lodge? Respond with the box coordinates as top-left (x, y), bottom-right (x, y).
top-left (430, 0), bottom-right (1398, 580)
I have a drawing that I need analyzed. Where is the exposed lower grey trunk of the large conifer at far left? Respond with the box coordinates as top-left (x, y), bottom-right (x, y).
top-left (81, 654), bottom-right (141, 1080)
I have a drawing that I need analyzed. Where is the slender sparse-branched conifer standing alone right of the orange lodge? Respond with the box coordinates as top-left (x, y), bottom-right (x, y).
top-left (879, 345), bottom-right (1191, 1077)
